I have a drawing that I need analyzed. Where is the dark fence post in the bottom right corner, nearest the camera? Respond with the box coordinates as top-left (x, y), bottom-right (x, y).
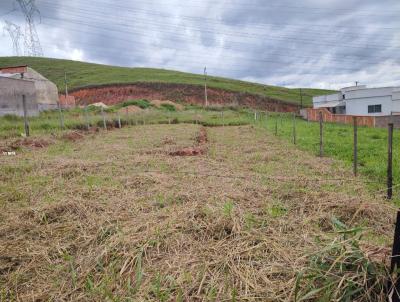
top-left (388, 211), bottom-right (400, 302)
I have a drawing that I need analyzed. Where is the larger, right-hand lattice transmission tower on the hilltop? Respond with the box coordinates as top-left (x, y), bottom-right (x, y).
top-left (16, 0), bottom-right (43, 57)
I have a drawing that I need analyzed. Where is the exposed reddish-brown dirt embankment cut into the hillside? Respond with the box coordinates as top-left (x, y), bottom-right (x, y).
top-left (71, 83), bottom-right (299, 112)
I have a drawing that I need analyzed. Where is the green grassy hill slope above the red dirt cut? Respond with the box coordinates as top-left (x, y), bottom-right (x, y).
top-left (0, 57), bottom-right (332, 105)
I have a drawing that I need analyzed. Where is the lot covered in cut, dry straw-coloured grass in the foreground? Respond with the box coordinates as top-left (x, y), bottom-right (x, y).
top-left (0, 125), bottom-right (395, 301)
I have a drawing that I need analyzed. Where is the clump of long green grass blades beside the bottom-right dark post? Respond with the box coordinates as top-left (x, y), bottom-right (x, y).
top-left (295, 218), bottom-right (390, 302)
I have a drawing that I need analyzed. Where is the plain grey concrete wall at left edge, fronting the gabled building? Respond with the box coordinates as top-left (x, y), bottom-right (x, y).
top-left (0, 77), bottom-right (39, 116)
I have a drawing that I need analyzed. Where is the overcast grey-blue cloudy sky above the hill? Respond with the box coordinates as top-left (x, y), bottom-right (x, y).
top-left (0, 0), bottom-right (400, 89)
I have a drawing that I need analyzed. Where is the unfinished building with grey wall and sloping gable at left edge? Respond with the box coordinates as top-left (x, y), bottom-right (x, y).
top-left (0, 66), bottom-right (58, 116)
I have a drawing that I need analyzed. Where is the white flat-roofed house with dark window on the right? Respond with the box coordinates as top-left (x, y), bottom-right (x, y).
top-left (313, 86), bottom-right (400, 116)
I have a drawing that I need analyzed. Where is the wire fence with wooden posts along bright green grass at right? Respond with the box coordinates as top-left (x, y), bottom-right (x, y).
top-left (254, 111), bottom-right (400, 199)
